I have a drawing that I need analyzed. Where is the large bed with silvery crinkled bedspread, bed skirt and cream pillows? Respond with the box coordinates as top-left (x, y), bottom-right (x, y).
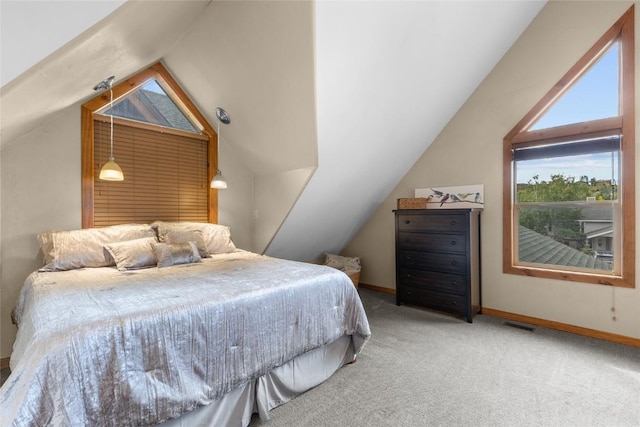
top-left (0, 222), bottom-right (370, 427)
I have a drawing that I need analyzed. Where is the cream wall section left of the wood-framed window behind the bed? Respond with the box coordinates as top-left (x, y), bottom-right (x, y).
top-left (0, 106), bottom-right (82, 357)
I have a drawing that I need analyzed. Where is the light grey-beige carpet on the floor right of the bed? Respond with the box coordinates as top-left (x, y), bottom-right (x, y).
top-left (252, 289), bottom-right (640, 427)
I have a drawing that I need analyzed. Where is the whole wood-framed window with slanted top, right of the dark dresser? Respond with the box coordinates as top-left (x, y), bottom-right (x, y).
top-left (503, 7), bottom-right (635, 287)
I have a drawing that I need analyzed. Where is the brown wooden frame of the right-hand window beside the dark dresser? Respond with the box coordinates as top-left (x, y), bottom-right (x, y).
top-left (502, 6), bottom-right (636, 288)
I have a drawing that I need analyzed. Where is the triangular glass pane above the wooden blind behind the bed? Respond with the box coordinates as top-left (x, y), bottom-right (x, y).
top-left (98, 78), bottom-right (202, 134)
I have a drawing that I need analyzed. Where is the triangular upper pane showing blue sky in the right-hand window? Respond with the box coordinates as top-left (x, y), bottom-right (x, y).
top-left (528, 42), bottom-right (620, 130)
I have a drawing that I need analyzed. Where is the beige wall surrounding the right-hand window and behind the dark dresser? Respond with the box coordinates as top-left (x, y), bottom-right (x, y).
top-left (344, 1), bottom-right (640, 338)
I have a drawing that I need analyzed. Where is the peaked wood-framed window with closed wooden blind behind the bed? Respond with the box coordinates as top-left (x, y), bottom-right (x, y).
top-left (82, 64), bottom-right (217, 227)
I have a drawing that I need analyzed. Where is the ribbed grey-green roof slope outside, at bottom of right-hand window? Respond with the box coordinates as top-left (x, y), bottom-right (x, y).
top-left (518, 226), bottom-right (610, 270)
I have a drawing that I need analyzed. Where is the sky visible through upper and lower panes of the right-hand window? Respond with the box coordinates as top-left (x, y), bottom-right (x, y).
top-left (516, 43), bottom-right (619, 183)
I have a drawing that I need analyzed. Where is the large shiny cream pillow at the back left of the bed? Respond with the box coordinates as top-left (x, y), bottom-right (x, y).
top-left (37, 224), bottom-right (156, 271)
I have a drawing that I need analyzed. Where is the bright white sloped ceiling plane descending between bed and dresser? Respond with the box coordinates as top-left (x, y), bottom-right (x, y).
top-left (267, 1), bottom-right (545, 260)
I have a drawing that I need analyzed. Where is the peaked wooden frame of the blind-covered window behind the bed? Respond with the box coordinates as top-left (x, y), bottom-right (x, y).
top-left (81, 62), bottom-right (218, 228)
